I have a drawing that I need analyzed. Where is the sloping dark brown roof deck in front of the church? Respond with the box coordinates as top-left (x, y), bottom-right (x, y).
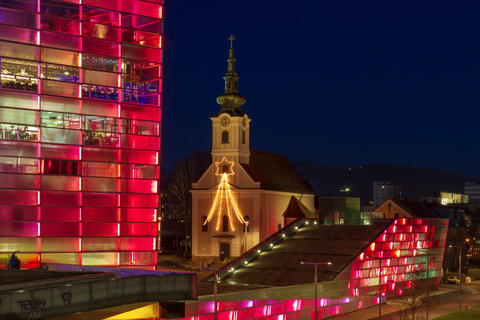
top-left (203, 225), bottom-right (384, 292)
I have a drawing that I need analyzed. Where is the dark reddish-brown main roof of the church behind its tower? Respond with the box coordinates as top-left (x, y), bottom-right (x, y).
top-left (241, 149), bottom-right (315, 194)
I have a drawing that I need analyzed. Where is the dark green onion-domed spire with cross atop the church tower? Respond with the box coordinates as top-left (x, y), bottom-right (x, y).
top-left (216, 36), bottom-right (246, 116)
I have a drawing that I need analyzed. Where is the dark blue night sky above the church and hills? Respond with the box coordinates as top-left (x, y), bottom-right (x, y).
top-left (162, 0), bottom-right (480, 177)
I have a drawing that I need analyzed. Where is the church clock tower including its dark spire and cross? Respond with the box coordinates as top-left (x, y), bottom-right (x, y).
top-left (210, 36), bottom-right (250, 164)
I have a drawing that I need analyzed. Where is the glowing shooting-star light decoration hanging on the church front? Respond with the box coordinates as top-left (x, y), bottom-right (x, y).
top-left (203, 157), bottom-right (245, 231)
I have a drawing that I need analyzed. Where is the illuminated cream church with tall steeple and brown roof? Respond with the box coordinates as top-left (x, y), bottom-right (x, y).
top-left (191, 37), bottom-right (315, 261)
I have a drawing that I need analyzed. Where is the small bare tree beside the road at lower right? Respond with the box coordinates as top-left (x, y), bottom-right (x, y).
top-left (400, 269), bottom-right (435, 320)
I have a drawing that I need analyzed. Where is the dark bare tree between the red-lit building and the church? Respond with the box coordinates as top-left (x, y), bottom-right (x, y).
top-left (166, 149), bottom-right (212, 257)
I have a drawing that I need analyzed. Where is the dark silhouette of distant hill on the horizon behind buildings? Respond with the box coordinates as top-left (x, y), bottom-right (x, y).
top-left (293, 161), bottom-right (480, 205)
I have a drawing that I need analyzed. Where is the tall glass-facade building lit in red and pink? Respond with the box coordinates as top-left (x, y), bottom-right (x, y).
top-left (0, 0), bottom-right (163, 268)
